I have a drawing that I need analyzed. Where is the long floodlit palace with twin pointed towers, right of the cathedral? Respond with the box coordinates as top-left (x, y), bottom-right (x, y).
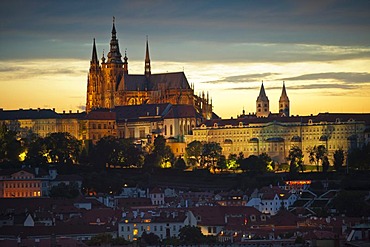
top-left (186, 84), bottom-right (370, 164)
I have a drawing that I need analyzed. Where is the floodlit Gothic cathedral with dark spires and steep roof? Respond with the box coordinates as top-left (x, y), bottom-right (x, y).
top-left (86, 20), bottom-right (212, 119)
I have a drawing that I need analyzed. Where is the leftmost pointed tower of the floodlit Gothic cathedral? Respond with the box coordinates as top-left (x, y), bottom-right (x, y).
top-left (86, 39), bottom-right (103, 112)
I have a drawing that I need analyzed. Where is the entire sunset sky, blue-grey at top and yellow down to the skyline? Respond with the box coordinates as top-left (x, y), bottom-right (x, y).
top-left (0, 0), bottom-right (370, 118)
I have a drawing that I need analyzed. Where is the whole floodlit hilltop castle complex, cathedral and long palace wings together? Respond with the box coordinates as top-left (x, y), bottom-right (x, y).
top-left (0, 21), bottom-right (370, 163)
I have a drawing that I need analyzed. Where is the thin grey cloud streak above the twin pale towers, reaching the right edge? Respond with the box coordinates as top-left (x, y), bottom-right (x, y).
top-left (280, 72), bottom-right (370, 85)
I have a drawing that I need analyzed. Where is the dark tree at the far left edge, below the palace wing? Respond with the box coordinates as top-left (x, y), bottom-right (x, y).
top-left (0, 124), bottom-right (22, 161)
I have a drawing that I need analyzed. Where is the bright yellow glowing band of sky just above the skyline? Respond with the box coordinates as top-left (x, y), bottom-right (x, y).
top-left (0, 56), bottom-right (370, 118)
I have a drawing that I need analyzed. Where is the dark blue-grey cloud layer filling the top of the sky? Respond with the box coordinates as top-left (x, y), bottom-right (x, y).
top-left (0, 0), bottom-right (370, 61)
